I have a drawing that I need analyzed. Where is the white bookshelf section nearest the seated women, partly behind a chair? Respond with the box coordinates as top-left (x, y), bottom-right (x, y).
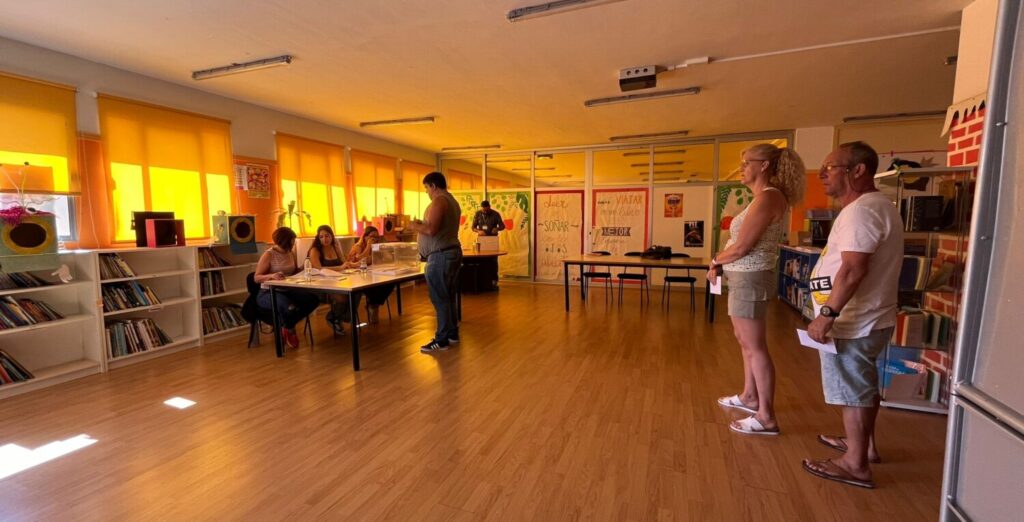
top-left (196, 244), bottom-right (260, 341)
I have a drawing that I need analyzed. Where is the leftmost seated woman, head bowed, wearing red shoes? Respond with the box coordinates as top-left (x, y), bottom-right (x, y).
top-left (255, 226), bottom-right (319, 348)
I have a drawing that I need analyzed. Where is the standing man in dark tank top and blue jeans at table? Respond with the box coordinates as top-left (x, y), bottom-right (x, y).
top-left (409, 172), bottom-right (462, 353)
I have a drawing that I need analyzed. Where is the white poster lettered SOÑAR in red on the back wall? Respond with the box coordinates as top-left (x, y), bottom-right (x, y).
top-left (536, 190), bottom-right (583, 280)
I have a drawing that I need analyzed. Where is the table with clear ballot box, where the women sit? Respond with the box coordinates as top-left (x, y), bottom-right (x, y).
top-left (264, 263), bottom-right (424, 372)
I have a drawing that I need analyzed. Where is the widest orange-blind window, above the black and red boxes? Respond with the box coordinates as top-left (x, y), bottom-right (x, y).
top-left (99, 95), bottom-right (234, 242)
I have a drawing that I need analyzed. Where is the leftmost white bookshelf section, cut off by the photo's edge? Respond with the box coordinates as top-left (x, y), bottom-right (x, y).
top-left (0, 252), bottom-right (105, 399)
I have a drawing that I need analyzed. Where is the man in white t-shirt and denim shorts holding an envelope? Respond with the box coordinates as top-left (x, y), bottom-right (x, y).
top-left (804, 141), bottom-right (903, 488)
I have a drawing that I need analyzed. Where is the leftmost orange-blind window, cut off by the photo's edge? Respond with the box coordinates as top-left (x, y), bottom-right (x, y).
top-left (0, 74), bottom-right (81, 240)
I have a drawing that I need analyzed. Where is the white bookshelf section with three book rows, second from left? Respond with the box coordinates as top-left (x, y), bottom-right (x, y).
top-left (95, 247), bottom-right (202, 369)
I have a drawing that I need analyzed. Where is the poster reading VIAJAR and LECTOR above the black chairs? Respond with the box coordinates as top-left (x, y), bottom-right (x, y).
top-left (592, 188), bottom-right (647, 256)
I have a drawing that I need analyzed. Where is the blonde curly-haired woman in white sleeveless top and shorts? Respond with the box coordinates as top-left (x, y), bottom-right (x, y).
top-left (708, 143), bottom-right (807, 435)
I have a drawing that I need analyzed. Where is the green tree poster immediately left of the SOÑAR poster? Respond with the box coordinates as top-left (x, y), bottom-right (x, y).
top-left (485, 190), bottom-right (532, 277)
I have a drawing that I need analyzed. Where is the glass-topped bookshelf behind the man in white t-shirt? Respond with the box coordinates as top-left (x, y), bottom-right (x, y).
top-left (874, 167), bottom-right (974, 414)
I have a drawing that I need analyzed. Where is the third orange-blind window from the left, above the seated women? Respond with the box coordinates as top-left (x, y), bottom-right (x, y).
top-left (278, 133), bottom-right (351, 237)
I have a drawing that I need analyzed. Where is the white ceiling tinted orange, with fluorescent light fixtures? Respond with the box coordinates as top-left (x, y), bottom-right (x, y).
top-left (0, 0), bottom-right (970, 151)
